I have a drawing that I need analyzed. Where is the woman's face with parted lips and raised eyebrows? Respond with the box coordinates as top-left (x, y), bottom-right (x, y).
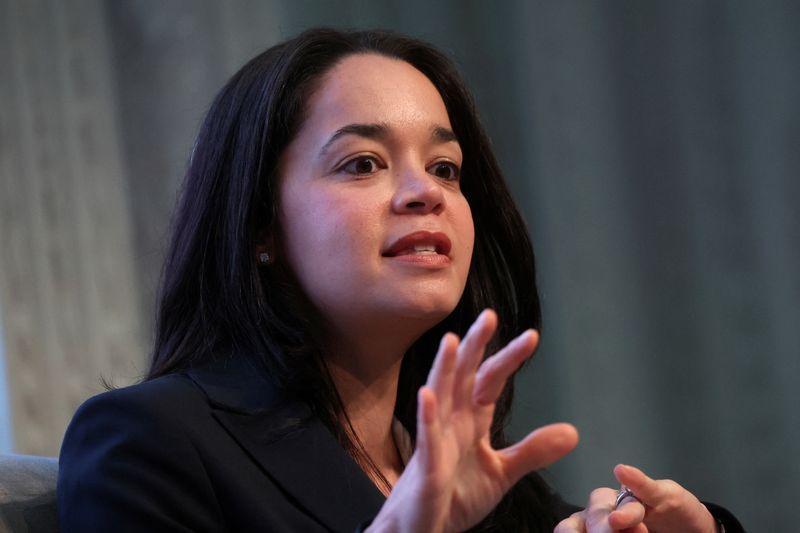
top-left (278, 54), bottom-right (474, 338)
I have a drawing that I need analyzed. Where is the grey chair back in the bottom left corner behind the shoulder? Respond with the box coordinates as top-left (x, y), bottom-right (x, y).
top-left (0, 454), bottom-right (58, 533)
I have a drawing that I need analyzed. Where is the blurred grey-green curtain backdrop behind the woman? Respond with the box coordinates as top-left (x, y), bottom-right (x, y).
top-left (0, 0), bottom-right (800, 531)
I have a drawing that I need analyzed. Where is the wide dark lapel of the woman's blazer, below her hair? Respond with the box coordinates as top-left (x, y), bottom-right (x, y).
top-left (188, 357), bottom-right (385, 531)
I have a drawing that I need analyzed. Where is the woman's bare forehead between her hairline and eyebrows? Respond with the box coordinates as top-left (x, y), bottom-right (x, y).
top-left (307, 54), bottom-right (450, 133)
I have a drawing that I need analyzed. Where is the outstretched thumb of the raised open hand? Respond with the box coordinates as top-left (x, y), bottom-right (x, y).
top-left (499, 423), bottom-right (578, 486)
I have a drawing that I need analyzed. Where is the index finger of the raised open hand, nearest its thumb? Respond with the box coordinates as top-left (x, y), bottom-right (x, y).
top-left (472, 329), bottom-right (539, 405)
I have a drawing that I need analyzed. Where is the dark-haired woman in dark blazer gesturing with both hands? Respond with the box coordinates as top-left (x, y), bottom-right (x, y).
top-left (58, 30), bottom-right (744, 531)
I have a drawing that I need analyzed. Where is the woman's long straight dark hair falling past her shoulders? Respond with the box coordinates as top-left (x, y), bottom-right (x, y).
top-left (147, 29), bottom-right (554, 531)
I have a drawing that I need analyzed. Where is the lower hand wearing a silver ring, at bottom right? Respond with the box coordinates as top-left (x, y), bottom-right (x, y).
top-left (555, 465), bottom-right (717, 533)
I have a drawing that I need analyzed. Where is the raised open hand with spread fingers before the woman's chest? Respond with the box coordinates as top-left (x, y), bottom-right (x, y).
top-left (369, 310), bottom-right (578, 532)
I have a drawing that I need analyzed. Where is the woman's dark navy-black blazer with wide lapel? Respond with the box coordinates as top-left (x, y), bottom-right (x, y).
top-left (57, 358), bottom-right (740, 533)
